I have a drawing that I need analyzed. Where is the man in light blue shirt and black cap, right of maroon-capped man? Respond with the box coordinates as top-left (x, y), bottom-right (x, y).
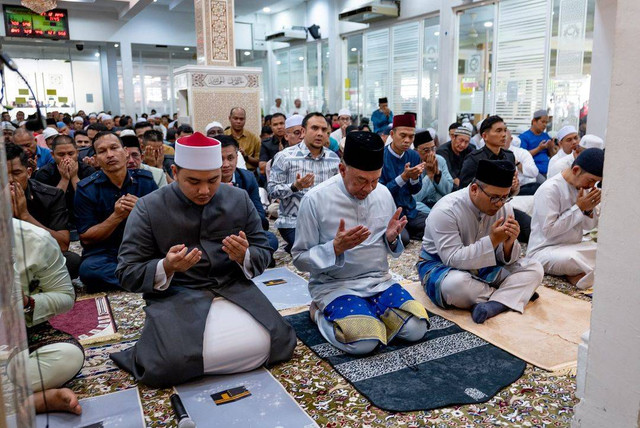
top-left (413, 131), bottom-right (453, 215)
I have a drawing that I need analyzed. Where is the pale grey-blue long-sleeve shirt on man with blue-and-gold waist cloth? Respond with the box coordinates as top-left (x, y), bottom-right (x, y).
top-left (291, 175), bottom-right (404, 309)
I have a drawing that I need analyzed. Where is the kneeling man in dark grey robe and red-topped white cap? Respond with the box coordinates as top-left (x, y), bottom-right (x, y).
top-left (111, 132), bottom-right (296, 387)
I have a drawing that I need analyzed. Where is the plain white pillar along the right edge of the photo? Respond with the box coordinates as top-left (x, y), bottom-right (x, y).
top-left (573, 0), bottom-right (640, 428)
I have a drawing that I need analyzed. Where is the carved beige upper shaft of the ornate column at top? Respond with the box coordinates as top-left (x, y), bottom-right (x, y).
top-left (194, 0), bottom-right (236, 67)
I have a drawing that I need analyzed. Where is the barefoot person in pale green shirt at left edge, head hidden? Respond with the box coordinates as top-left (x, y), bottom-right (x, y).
top-left (11, 219), bottom-right (84, 414)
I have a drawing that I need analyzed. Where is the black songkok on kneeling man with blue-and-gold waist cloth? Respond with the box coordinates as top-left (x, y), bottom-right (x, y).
top-left (343, 131), bottom-right (384, 171)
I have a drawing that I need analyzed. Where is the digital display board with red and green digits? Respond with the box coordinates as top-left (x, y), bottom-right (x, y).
top-left (3, 5), bottom-right (69, 39)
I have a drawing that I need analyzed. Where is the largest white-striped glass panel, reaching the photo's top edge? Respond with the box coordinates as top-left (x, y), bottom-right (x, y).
top-left (492, 0), bottom-right (550, 128)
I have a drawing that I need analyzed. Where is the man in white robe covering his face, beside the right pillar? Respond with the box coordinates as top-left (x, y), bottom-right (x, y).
top-left (527, 148), bottom-right (604, 289)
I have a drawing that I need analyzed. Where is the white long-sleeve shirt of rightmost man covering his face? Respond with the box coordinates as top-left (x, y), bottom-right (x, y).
top-left (527, 174), bottom-right (598, 255)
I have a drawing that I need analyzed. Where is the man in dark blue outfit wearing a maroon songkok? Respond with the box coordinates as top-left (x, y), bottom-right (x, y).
top-left (380, 114), bottom-right (427, 245)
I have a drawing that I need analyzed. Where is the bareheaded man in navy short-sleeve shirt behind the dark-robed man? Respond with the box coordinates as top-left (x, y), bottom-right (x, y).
top-left (74, 131), bottom-right (158, 287)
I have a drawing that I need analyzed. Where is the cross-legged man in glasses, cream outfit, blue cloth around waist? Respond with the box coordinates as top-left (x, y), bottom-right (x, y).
top-left (416, 159), bottom-right (544, 324)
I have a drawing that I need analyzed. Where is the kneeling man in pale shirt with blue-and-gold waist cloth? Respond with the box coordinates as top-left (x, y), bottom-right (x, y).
top-left (292, 132), bottom-right (428, 354)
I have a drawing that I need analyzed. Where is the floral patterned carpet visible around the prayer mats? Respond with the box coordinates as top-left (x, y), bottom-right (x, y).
top-left (68, 237), bottom-right (591, 428)
